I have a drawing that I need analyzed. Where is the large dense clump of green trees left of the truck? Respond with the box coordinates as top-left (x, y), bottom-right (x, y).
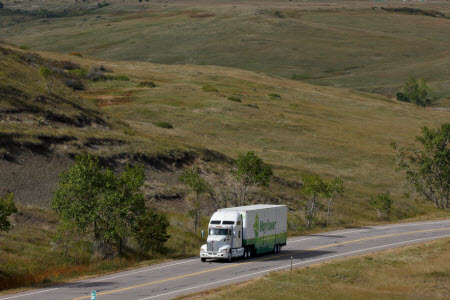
top-left (52, 155), bottom-right (167, 255)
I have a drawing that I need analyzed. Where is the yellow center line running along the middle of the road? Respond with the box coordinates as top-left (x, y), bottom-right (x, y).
top-left (73, 227), bottom-right (450, 300)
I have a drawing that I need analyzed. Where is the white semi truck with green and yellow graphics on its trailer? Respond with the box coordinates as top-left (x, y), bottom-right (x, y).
top-left (200, 204), bottom-right (287, 262)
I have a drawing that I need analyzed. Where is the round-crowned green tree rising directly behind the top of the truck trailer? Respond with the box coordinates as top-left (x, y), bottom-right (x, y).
top-left (233, 151), bottom-right (273, 205)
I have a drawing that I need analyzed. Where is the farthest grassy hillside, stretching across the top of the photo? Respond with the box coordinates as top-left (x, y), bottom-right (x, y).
top-left (0, 0), bottom-right (450, 101)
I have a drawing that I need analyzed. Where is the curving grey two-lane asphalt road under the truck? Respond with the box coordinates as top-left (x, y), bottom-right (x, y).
top-left (0, 219), bottom-right (450, 300)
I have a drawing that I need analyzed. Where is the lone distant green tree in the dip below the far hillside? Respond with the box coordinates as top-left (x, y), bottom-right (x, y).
top-left (397, 77), bottom-right (435, 107)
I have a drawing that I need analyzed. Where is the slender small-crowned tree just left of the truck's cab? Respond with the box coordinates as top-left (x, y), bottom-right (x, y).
top-left (180, 168), bottom-right (208, 233)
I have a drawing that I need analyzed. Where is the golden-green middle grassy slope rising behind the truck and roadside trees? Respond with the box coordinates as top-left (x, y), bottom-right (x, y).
top-left (32, 48), bottom-right (448, 218)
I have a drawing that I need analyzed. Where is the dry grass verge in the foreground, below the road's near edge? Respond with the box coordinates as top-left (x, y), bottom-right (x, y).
top-left (182, 239), bottom-right (450, 299)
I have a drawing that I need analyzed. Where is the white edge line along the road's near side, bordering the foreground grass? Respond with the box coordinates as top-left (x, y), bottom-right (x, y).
top-left (139, 235), bottom-right (450, 300)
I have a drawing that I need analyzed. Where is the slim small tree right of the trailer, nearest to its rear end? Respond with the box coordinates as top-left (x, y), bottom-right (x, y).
top-left (302, 175), bottom-right (326, 229)
